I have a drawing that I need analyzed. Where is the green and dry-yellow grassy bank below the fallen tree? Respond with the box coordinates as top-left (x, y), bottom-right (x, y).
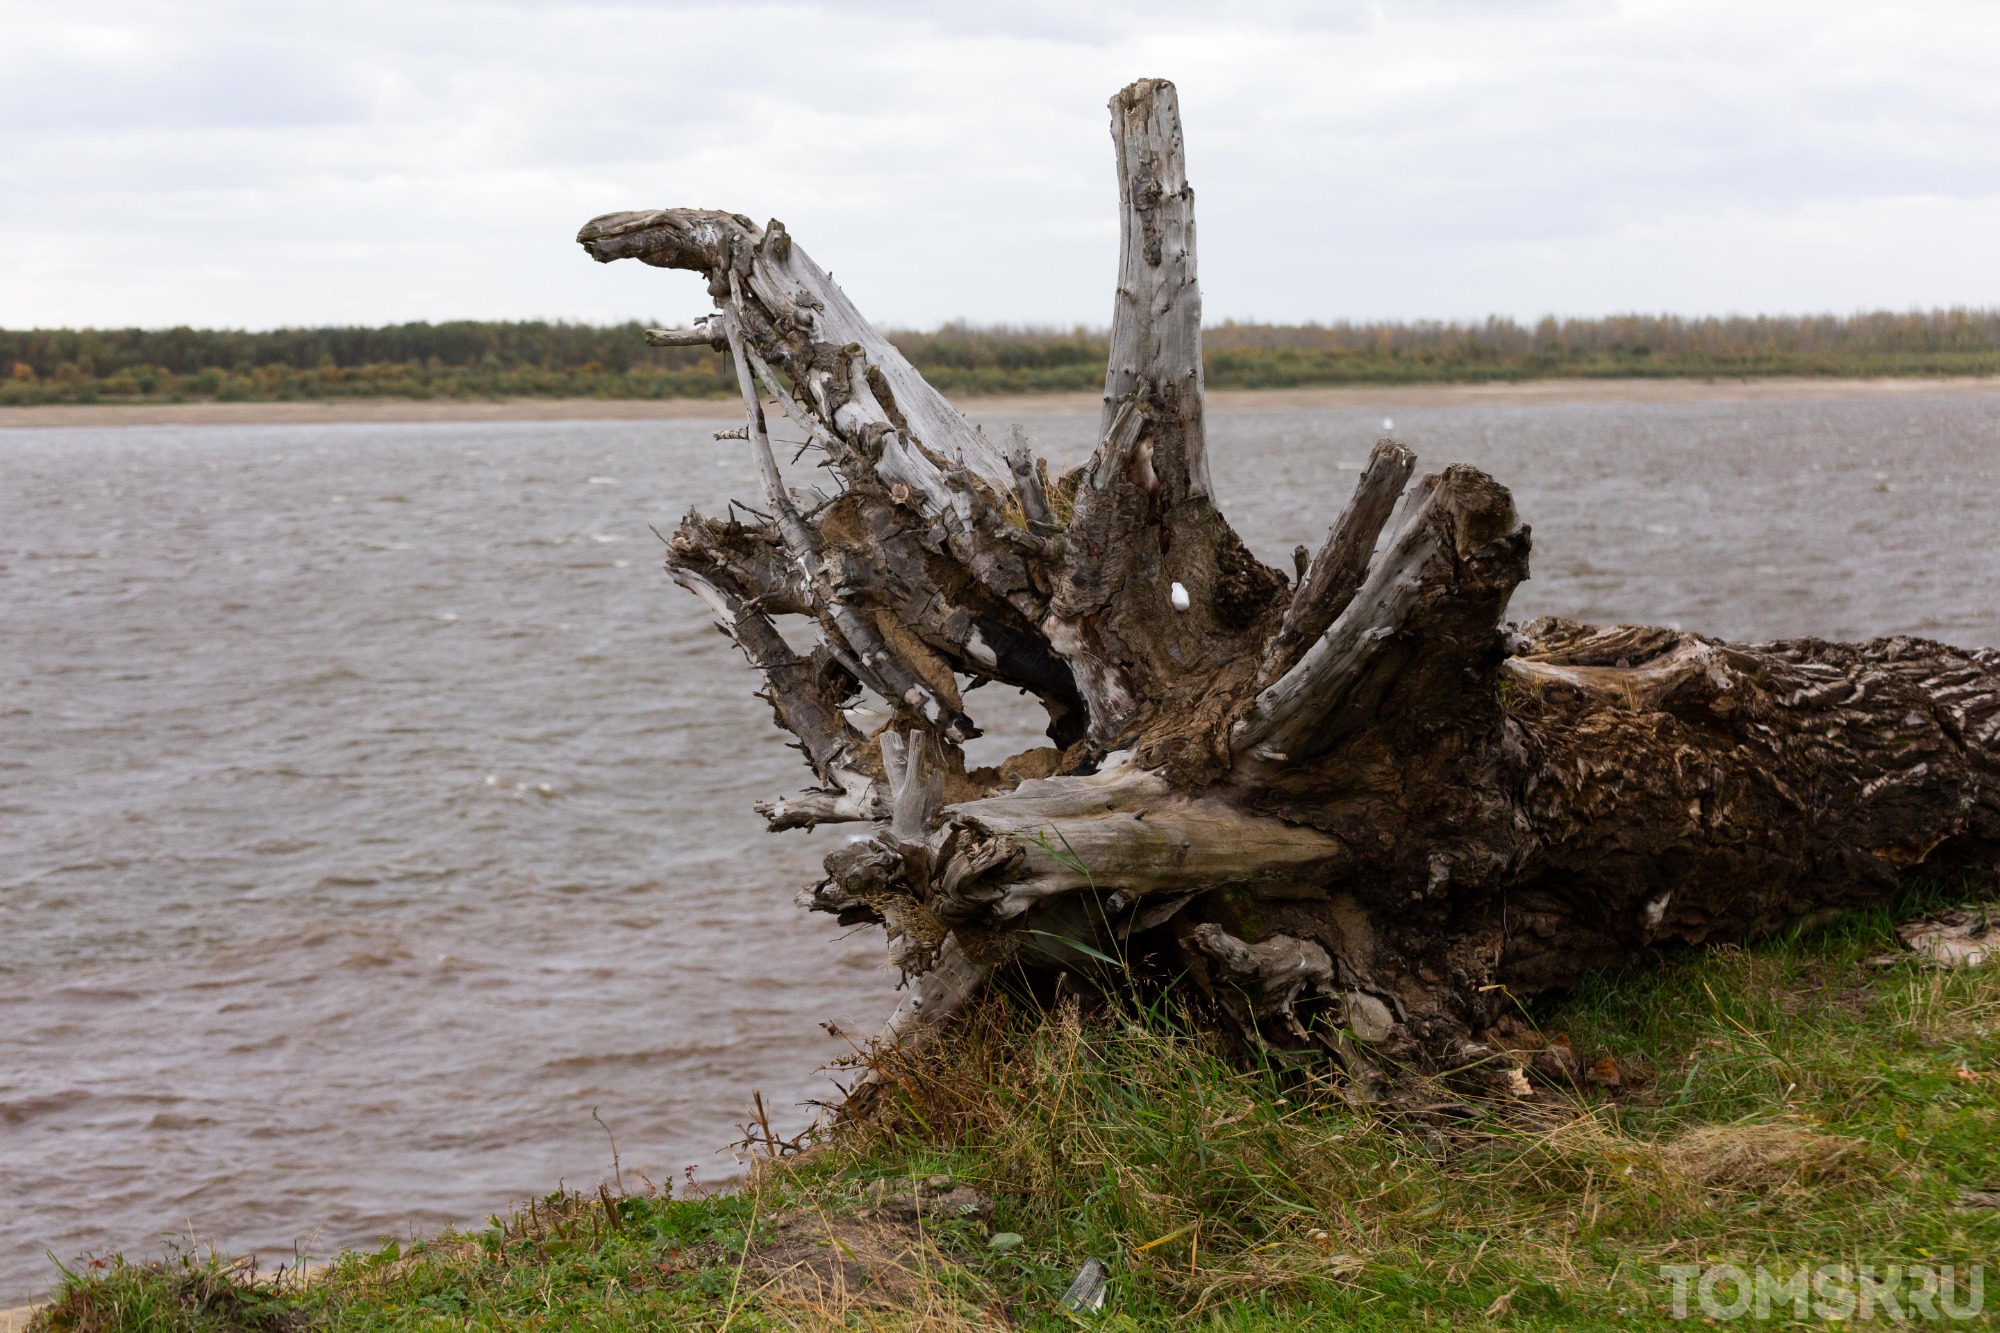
top-left (31, 880), bottom-right (2000, 1331)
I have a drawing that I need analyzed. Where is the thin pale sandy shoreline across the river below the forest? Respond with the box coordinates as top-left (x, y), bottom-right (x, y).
top-left (0, 376), bottom-right (2000, 430)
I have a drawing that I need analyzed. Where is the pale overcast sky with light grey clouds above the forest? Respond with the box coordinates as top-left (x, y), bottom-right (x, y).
top-left (0, 0), bottom-right (2000, 328)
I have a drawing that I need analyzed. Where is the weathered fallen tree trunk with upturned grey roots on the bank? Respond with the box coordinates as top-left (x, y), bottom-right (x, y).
top-left (578, 80), bottom-right (2000, 1089)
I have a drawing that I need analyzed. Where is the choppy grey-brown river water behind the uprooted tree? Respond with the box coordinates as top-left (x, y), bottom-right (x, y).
top-left (0, 396), bottom-right (2000, 1305)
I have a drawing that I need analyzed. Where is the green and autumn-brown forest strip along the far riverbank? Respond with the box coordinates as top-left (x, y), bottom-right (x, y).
top-left (0, 308), bottom-right (2000, 404)
